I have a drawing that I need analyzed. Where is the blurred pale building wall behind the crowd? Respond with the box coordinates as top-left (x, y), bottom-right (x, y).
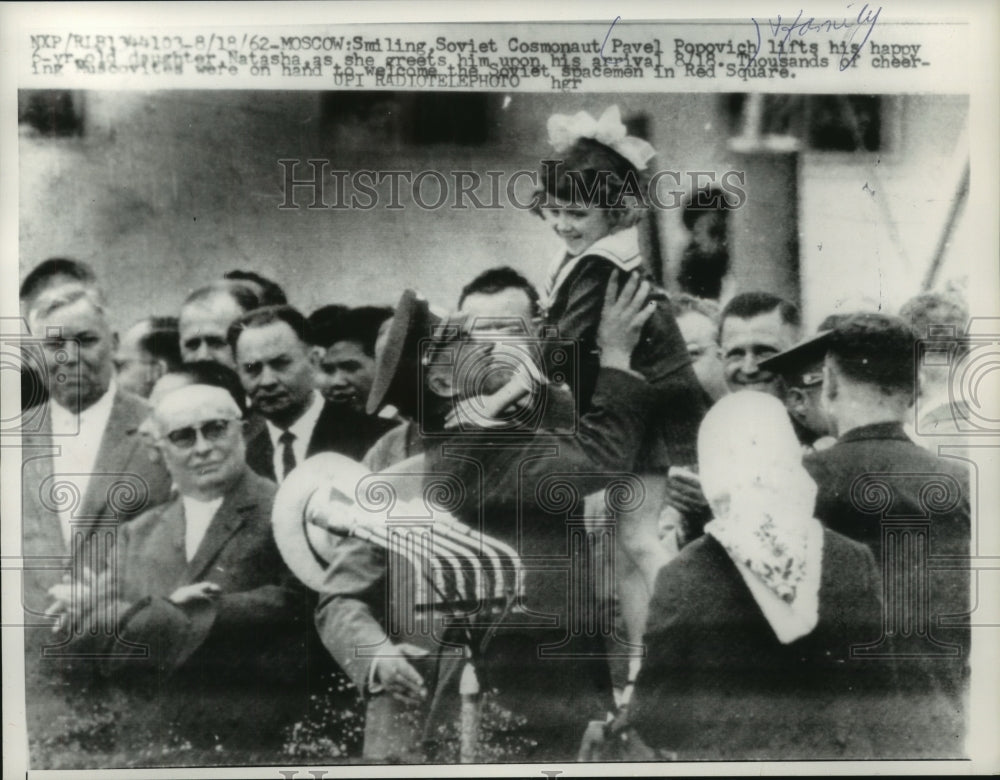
top-left (19, 91), bottom-right (975, 334)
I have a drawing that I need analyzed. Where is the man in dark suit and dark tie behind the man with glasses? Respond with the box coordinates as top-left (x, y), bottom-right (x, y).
top-left (229, 306), bottom-right (396, 482)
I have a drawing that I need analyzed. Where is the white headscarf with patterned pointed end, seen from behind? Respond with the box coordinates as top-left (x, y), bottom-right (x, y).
top-left (698, 390), bottom-right (823, 643)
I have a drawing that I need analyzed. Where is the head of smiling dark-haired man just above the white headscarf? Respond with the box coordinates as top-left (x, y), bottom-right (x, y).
top-left (719, 292), bottom-right (801, 400)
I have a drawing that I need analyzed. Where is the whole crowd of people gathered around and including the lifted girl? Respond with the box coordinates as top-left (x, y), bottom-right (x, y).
top-left (13, 105), bottom-right (971, 767)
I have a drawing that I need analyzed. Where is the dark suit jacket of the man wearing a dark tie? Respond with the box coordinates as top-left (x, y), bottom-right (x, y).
top-left (247, 401), bottom-right (399, 480)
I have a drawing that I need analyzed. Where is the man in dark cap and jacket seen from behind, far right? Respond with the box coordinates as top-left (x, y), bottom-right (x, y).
top-left (804, 313), bottom-right (971, 757)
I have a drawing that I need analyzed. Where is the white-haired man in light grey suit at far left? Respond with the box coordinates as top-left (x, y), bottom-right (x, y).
top-left (21, 274), bottom-right (170, 614)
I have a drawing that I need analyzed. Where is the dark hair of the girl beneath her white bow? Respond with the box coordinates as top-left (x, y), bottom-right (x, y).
top-left (531, 138), bottom-right (647, 220)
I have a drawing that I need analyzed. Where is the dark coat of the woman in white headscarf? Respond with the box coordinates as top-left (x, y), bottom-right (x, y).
top-left (629, 530), bottom-right (894, 760)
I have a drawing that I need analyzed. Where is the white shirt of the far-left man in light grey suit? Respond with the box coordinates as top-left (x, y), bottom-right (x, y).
top-left (49, 378), bottom-right (118, 546)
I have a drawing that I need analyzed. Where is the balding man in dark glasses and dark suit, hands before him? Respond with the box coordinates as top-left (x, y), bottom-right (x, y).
top-left (50, 364), bottom-right (313, 760)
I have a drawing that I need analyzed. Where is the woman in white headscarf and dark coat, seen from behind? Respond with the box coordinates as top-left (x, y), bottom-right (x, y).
top-left (628, 391), bottom-right (891, 759)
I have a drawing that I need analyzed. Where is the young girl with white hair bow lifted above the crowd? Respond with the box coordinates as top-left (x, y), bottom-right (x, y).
top-left (534, 106), bottom-right (707, 474)
